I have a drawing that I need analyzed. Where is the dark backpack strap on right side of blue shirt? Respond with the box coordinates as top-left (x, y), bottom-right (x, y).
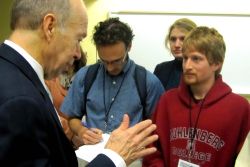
top-left (134, 65), bottom-right (147, 119)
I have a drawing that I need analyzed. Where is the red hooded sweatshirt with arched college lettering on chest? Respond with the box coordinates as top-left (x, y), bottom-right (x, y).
top-left (143, 76), bottom-right (250, 167)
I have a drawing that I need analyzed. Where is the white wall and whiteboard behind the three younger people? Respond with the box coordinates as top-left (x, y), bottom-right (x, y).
top-left (110, 0), bottom-right (250, 94)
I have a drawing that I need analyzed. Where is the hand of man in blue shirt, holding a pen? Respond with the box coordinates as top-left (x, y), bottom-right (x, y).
top-left (78, 127), bottom-right (102, 144)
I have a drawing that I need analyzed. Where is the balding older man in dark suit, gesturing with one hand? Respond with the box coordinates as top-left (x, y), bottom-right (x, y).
top-left (0, 0), bottom-right (158, 167)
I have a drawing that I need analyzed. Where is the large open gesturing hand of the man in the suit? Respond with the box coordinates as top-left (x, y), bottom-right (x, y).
top-left (105, 114), bottom-right (158, 165)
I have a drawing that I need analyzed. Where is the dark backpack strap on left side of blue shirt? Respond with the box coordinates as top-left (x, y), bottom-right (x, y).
top-left (83, 63), bottom-right (100, 114)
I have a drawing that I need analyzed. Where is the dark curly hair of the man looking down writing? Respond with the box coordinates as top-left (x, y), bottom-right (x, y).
top-left (93, 18), bottom-right (134, 48)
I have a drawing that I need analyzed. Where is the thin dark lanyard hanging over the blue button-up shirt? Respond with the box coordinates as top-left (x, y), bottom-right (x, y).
top-left (103, 70), bottom-right (127, 130)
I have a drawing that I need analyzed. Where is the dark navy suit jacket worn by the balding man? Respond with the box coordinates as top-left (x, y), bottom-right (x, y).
top-left (0, 44), bottom-right (114, 167)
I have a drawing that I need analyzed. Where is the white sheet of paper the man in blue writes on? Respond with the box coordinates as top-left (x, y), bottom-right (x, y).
top-left (75, 134), bottom-right (110, 162)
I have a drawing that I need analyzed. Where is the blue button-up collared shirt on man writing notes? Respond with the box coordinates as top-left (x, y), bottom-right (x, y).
top-left (61, 59), bottom-right (164, 133)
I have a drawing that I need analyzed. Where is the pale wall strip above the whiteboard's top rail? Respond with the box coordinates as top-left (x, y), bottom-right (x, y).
top-left (109, 0), bottom-right (250, 14)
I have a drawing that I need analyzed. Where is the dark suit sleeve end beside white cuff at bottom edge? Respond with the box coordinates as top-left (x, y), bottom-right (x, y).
top-left (87, 154), bottom-right (115, 167)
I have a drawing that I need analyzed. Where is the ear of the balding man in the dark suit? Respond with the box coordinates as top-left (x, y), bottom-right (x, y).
top-left (42, 14), bottom-right (56, 41)
